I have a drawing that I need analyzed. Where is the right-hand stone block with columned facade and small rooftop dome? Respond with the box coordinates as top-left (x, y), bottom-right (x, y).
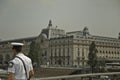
top-left (49, 27), bottom-right (120, 67)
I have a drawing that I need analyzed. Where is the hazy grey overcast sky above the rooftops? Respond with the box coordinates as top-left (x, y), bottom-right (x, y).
top-left (0, 0), bottom-right (120, 40)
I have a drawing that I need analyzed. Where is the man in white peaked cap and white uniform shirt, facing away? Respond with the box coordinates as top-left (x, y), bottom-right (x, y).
top-left (8, 42), bottom-right (34, 80)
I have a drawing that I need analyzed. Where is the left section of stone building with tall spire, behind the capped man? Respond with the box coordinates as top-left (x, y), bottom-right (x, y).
top-left (0, 20), bottom-right (65, 64)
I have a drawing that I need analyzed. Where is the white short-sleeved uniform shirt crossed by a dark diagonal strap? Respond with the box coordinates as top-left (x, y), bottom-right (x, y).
top-left (8, 53), bottom-right (33, 80)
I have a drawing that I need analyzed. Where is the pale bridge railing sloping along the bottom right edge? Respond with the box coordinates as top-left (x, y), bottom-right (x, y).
top-left (31, 72), bottom-right (120, 80)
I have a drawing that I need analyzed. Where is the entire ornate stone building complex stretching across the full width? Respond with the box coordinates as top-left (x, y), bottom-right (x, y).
top-left (0, 20), bottom-right (120, 67)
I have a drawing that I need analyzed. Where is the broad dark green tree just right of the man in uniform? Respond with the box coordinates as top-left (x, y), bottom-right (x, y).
top-left (28, 41), bottom-right (42, 67)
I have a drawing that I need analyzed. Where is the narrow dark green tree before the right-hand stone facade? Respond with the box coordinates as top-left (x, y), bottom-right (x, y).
top-left (88, 42), bottom-right (98, 73)
